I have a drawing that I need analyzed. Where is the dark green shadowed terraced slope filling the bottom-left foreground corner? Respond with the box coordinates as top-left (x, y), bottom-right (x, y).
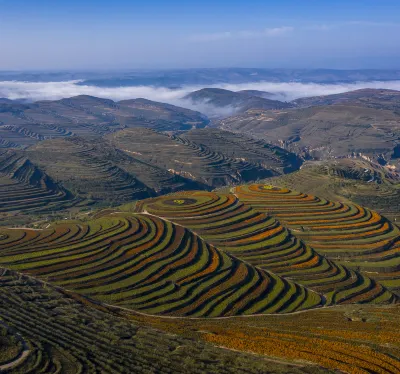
top-left (0, 269), bottom-right (312, 374)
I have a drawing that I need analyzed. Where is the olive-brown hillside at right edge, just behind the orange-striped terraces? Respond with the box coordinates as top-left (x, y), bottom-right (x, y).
top-left (264, 158), bottom-right (400, 221)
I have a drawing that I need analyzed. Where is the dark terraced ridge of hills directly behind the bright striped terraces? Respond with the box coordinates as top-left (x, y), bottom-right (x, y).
top-left (0, 127), bottom-right (301, 224)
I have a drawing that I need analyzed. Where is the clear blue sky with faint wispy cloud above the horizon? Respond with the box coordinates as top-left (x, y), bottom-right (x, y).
top-left (0, 0), bottom-right (400, 70)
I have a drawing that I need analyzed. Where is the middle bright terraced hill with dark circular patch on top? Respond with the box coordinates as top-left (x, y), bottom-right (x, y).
top-left (140, 191), bottom-right (397, 305)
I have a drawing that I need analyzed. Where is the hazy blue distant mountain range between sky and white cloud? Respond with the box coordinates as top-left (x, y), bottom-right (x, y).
top-left (0, 68), bottom-right (400, 87)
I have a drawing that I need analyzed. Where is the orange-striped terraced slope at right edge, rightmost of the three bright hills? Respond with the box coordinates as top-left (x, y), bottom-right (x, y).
top-left (234, 184), bottom-right (400, 291)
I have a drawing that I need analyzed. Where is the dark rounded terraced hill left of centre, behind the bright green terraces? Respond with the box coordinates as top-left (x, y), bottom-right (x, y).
top-left (25, 137), bottom-right (154, 202)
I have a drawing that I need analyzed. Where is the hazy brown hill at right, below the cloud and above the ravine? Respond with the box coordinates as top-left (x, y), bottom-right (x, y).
top-left (218, 103), bottom-right (400, 164)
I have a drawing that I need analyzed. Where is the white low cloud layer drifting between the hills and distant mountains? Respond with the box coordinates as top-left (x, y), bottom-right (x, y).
top-left (0, 81), bottom-right (400, 116)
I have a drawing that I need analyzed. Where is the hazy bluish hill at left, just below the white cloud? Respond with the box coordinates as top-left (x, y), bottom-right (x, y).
top-left (0, 96), bottom-right (209, 148)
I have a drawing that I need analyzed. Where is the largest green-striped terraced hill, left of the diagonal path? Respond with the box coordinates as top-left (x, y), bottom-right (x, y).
top-left (0, 213), bottom-right (324, 317)
